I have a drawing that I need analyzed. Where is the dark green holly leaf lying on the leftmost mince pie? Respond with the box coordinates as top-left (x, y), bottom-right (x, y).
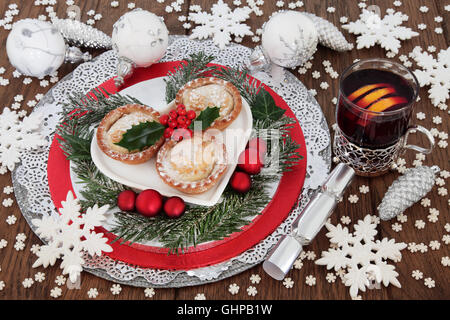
top-left (115, 121), bottom-right (165, 151)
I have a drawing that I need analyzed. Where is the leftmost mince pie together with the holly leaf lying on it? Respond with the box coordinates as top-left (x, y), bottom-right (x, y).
top-left (97, 104), bottom-right (164, 164)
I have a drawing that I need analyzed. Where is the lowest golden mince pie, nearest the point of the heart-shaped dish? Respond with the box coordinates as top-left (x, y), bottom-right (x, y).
top-left (156, 135), bottom-right (227, 194)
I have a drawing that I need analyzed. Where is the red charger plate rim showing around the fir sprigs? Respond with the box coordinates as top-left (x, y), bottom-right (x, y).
top-left (47, 61), bottom-right (307, 270)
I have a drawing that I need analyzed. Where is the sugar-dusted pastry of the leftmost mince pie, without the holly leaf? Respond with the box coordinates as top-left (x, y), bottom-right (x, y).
top-left (97, 104), bottom-right (164, 164)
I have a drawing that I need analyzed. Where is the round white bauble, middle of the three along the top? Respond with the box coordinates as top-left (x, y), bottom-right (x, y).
top-left (112, 9), bottom-right (169, 67)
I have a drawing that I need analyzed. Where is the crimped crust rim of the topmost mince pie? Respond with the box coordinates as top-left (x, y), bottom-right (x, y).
top-left (175, 77), bottom-right (242, 130)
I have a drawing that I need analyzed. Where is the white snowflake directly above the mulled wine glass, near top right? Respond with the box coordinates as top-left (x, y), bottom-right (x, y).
top-left (342, 9), bottom-right (419, 53)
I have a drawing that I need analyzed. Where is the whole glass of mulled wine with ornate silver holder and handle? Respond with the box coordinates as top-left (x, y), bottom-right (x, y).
top-left (334, 59), bottom-right (434, 176)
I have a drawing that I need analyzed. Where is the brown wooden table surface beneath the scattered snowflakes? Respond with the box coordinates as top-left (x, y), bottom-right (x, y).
top-left (0, 0), bottom-right (450, 300)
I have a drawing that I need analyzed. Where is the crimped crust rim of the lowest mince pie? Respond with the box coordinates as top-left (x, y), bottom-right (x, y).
top-left (156, 134), bottom-right (228, 194)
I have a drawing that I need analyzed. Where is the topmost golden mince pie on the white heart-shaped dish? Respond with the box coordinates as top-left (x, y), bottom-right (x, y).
top-left (175, 77), bottom-right (242, 130)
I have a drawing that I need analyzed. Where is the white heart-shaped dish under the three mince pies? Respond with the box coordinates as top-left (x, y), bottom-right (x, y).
top-left (91, 77), bottom-right (253, 206)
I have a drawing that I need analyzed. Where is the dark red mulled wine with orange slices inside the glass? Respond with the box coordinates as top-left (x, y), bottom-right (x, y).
top-left (336, 68), bottom-right (416, 149)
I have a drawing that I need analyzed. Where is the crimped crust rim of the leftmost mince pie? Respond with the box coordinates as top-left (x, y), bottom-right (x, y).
top-left (97, 104), bottom-right (164, 164)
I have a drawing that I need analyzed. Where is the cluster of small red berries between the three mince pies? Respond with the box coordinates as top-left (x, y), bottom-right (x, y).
top-left (159, 104), bottom-right (197, 141)
